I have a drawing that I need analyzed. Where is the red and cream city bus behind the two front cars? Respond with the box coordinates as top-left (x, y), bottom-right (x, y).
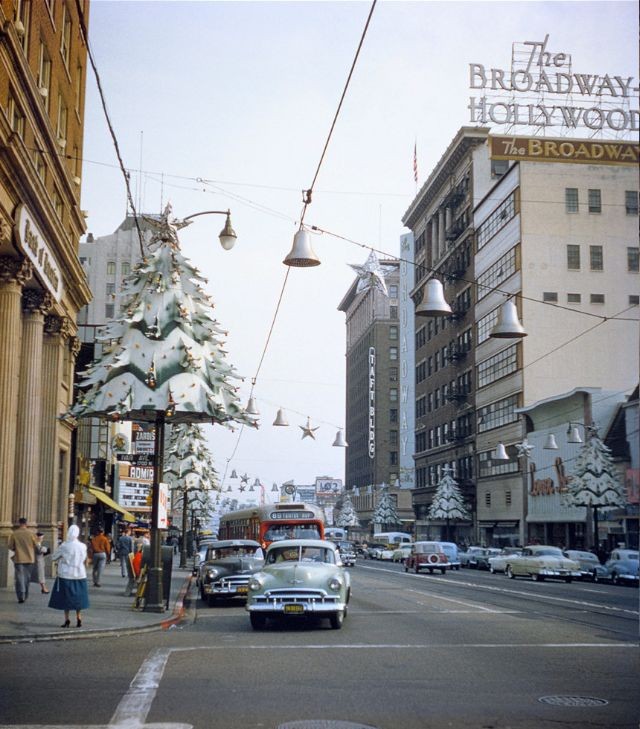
top-left (218, 502), bottom-right (324, 548)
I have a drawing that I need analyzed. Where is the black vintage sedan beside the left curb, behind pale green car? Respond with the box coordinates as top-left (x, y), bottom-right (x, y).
top-left (196, 539), bottom-right (264, 606)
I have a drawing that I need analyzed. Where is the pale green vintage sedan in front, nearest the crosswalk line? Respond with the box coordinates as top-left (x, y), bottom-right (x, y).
top-left (246, 539), bottom-right (351, 630)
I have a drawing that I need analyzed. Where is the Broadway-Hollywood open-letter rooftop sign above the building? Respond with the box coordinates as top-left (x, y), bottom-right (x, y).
top-left (468, 35), bottom-right (640, 132)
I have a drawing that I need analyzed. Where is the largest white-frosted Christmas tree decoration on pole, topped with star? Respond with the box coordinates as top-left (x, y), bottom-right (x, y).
top-left (70, 205), bottom-right (255, 612)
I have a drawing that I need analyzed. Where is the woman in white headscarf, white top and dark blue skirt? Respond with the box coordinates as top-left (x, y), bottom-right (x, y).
top-left (49, 524), bottom-right (89, 628)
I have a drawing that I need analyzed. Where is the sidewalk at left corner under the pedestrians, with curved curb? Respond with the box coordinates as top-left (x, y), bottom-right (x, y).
top-left (0, 560), bottom-right (191, 644)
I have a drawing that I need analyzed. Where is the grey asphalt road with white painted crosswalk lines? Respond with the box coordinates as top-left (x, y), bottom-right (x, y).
top-left (0, 560), bottom-right (640, 729)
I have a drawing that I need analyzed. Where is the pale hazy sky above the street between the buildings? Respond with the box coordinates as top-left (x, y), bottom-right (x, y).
top-left (82, 0), bottom-right (638, 492)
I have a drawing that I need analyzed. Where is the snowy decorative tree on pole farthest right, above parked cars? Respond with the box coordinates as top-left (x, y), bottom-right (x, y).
top-left (563, 425), bottom-right (625, 549)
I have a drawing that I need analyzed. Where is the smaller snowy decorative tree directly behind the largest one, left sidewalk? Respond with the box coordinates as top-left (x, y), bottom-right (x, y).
top-left (164, 423), bottom-right (218, 567)
